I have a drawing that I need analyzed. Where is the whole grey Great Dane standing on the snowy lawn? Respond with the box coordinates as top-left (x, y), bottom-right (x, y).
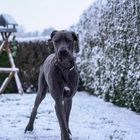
top-left (25, 30), bottom-right (79, 140)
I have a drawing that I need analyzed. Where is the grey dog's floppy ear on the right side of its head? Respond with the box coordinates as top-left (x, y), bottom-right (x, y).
top-left (71, 32), bottom-right (79, 53)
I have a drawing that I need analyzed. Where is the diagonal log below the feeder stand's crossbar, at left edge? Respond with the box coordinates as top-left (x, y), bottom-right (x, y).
top-left (0, 72), bottom-right (14, 94)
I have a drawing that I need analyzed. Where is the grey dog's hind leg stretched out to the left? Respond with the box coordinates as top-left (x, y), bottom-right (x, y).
top-left (25, 67), bottom-right (47, 133)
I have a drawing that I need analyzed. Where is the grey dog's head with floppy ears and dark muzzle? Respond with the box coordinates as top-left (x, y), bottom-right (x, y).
top-left (51, 30), bottom-right (79, 68)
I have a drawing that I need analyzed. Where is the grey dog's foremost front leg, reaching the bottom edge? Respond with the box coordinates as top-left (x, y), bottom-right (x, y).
top-left (55, 100), bottom-right (71, 140)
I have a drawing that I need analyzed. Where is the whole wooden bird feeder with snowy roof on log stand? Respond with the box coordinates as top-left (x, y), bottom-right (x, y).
top-left (0, 14), bottom-right (23, 94)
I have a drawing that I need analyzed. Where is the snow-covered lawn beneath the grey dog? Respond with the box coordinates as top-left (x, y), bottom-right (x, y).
top-left (0, 92), bottom-right (140, 140)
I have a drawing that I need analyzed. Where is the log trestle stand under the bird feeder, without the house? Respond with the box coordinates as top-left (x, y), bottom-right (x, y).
top-left (0, 32), bottom-right (23, 94)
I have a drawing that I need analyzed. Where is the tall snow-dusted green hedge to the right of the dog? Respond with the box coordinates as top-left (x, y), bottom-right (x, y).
top-left (73, 0), bottom-right (140, 112)
